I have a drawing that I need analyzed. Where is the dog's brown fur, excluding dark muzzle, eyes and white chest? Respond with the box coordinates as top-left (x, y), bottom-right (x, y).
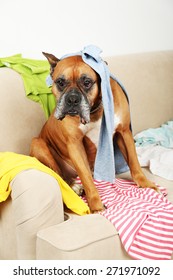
top-left (30, 53), bottom-right (157, 212)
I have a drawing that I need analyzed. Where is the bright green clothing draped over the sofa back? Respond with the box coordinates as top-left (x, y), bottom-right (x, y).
top-left (0, 54), bottom-right (56, 118)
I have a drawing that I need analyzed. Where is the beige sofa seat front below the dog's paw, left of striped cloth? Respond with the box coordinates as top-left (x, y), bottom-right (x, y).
top-left (37, 214), bottom-right (129, 260)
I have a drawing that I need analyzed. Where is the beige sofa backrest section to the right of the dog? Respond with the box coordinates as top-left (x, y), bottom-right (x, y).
top-left (105, 51), bottom-right (173, 134)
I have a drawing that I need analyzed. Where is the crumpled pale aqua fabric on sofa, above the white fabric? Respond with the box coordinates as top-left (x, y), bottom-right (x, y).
top-left (134, 120), bottom-right (173, 148)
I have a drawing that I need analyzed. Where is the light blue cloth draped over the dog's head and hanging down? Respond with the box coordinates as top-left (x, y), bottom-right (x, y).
top-left (56, 45), bottom-right (128, 183)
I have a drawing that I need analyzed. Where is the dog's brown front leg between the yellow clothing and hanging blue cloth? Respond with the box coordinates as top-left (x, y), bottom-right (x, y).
top-left (67, 139), bottom-right (104, 213)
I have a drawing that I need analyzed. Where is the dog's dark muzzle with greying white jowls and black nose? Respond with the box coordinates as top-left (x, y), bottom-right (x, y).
top-left (54, 89), bottom-right (90, 124)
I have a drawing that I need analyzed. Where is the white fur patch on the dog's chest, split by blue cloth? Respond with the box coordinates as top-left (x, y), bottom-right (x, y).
top-left (79, 115), bottom-right (120, 147)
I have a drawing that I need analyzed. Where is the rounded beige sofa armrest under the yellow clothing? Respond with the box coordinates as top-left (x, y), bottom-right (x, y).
top-left (11, 169), bottom-right (64, 259)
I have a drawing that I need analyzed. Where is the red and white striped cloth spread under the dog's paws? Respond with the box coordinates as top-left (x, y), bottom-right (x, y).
top-left (79, 179), bottom-right (173, 260)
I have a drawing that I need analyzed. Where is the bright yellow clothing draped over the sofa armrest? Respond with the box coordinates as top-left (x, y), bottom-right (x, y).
top-left (0, 152), bottom-right (90, 215)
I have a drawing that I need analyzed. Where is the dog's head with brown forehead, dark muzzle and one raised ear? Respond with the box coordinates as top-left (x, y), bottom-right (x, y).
top-left (43, 53), bottom-right (101, 124)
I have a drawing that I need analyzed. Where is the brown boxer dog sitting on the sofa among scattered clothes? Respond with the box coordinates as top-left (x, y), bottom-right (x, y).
top-left (30, 53), bottom-right (157, 213)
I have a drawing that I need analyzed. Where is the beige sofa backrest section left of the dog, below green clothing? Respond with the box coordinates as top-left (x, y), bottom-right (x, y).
top-left (0, 67), bottom-right (45, 154)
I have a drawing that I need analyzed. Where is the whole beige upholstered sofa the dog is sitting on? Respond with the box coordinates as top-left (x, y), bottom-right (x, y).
top-left (0, 51), bottom-right (173, 259)
